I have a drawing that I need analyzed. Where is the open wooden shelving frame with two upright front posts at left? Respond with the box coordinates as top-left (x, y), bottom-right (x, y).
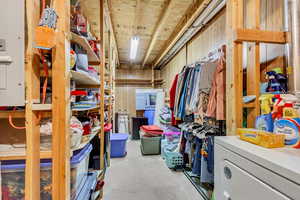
top-left (0, 0), bottom-right (118, 200)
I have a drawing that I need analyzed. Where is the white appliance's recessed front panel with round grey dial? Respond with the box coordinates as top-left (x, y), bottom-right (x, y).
top-left (223, 160), bottom-right (290, 200)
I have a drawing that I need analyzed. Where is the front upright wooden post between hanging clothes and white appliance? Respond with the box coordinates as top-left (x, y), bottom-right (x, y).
top-left (226, 0), bottom-right (244, 135)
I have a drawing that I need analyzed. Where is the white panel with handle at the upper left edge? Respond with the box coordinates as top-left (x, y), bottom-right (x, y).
top-left (0, 0), bottom-right (24, 106)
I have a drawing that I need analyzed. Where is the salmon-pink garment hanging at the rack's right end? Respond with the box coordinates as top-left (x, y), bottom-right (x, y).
top-left (206, 53), bottom-right (226, 120)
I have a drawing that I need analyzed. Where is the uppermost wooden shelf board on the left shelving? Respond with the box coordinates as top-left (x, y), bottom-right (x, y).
top-left (71, 32), bottom-right (100, 63)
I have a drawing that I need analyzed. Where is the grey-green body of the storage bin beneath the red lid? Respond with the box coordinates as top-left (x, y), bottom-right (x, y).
top-left (141, 137), bottom-right (161, 155)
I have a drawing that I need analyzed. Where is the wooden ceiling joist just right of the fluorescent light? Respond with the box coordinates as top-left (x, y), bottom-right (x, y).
top-left (142, 0), bottom-right (172, 67)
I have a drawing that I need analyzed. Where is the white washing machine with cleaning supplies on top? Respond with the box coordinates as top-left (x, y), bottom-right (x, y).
top-left (215, 136), bottom-right (300, 200)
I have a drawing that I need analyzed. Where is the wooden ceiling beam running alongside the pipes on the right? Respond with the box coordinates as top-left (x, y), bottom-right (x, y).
top-left (153, 0), bottom-right (212, 66)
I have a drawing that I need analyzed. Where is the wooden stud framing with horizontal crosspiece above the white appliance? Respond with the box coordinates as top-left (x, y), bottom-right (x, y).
top-left (226, 0), bottom-right (288, 135)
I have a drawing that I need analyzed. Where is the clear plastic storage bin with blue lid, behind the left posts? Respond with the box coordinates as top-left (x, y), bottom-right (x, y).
top-left (1, 145), bottom-right (92, 200)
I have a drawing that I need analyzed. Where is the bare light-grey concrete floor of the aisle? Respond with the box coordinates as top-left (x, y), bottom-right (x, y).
top-left (103, 140), bottom-right (201, 200)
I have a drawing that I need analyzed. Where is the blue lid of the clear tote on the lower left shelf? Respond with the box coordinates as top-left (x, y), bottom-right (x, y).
top-left (1, 144), bottom-right (93, 170)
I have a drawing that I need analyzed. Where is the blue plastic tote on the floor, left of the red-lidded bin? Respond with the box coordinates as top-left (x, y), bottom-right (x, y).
top-left (110, 133), bottom-right (128, 158)
